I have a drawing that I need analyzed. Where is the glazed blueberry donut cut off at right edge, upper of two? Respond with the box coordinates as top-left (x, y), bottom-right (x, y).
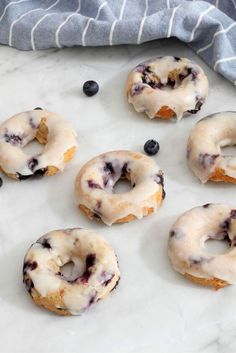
top-left (187, 112), bottom-right (236, 183)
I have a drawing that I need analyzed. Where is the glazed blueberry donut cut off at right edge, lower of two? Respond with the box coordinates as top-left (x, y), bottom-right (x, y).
top-left (168, 204), bottom-right (236, 289)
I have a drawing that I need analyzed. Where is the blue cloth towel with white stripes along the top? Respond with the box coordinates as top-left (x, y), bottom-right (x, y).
top-left (0, 0), bottom-right (236, 84)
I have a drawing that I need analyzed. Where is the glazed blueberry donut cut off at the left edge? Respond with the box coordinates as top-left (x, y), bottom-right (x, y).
top-left (0, 109), bottom-right (77, 180)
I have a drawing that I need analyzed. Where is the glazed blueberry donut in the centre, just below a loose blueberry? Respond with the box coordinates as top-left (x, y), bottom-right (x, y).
top-left (75, 151), bottom-right (165, 225)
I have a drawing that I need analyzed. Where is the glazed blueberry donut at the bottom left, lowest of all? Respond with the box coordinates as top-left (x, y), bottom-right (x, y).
top-left (23, 228), bottom-right (120, 315)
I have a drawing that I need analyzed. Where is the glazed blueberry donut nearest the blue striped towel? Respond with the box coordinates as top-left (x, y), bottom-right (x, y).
top-left (126, 56), bottom-right (208, 120)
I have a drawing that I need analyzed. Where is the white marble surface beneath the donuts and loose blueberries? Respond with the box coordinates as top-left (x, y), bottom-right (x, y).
top-left (0, 40), bottom-right (236, 353)
